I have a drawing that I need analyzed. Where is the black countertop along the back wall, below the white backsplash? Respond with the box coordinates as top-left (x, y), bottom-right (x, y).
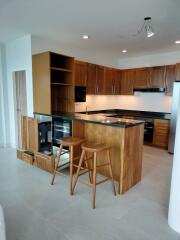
top-left (78, 109), bottom-right (171, 120)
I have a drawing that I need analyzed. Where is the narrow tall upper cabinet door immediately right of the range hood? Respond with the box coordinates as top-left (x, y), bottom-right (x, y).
top-left (165, 65), bottom-right (176, 96)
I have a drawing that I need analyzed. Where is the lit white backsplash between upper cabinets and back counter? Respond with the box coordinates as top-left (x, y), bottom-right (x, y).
top-left (75, 92), bottom-right (172, 113)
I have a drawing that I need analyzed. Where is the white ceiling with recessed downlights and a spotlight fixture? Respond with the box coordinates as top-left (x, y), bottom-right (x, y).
top-left (0, 0), bottom-right (180, 58)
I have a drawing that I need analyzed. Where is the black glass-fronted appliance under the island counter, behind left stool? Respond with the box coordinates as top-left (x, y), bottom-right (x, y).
top-left (52, 118), bottom-right (72, 147)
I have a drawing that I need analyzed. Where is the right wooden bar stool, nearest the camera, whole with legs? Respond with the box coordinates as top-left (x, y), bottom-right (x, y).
top-left (73, 142), bottom-right (116, 208)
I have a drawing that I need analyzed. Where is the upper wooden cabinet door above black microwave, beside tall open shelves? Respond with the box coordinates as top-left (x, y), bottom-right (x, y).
top-left (74, 60), bottom-right (87, 86)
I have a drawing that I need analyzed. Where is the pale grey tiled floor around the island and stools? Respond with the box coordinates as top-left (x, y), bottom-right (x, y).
top-left (0, 147), bottom-right (180, 240)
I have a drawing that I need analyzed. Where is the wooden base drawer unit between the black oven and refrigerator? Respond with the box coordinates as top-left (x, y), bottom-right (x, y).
top-left (153, 119), bottom-right (169, 149)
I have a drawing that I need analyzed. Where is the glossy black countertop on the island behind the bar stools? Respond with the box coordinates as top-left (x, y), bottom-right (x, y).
top-left (34, 112), bottom-right (144, 128)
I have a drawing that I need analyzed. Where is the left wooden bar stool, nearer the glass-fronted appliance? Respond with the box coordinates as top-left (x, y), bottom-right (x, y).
top-left (51, 137), bottom-right (85, 195)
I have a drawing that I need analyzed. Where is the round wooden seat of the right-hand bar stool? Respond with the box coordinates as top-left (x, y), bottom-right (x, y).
top-left (81, 142), bottom-right (111, 152)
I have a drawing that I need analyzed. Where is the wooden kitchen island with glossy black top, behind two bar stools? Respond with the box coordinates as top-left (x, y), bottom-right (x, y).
top-left (34, 112), bottom-right (144, 194)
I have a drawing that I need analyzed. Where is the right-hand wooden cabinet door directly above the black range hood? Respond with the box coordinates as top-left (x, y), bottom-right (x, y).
top-left (150, 66), bottom-right (166, 88)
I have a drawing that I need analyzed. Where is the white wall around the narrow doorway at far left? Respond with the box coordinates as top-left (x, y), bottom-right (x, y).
top-left (5, 35), bottom-right (33, 147)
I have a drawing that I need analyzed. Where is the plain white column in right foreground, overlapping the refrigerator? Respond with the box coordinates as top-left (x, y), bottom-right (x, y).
top-left (168, 88), bottom-right (180, 233)
